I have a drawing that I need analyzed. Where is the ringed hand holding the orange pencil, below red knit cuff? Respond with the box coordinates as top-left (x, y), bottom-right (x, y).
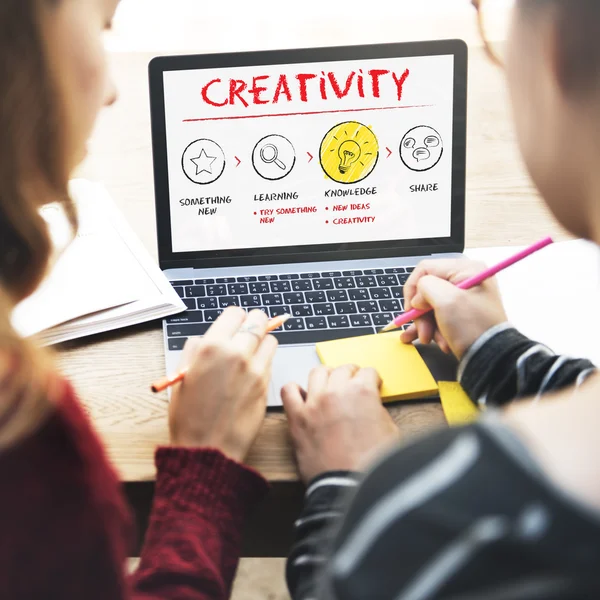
top-left (169, 307), bottom-right (277, 461)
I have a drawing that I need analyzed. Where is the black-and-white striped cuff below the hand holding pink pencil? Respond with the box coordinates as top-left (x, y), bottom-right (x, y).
top-left (458, 323), bottom-right (596, 407)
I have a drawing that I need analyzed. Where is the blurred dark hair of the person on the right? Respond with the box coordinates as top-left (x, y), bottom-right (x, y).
top-left (518, 0), bottom-right (600, 93)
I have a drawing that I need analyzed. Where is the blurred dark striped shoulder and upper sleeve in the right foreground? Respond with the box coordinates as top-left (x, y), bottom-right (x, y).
top-left (288, 424), bottom-right (600, 600)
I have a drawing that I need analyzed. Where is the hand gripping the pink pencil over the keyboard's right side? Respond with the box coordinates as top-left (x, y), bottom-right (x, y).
top-left (402, 259), bottom-right (506, 359)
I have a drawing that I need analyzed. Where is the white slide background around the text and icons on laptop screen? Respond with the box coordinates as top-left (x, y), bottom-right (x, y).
top-left (164, 55), bottom-right (454, 252)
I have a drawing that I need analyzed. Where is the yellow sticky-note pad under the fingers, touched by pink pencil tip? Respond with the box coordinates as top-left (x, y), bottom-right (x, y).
top-left (317, 333), bottom-right (438, 402)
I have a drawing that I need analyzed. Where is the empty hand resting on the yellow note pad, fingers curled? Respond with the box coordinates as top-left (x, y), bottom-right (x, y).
top-left (281, 365), bottom-right (398, 482)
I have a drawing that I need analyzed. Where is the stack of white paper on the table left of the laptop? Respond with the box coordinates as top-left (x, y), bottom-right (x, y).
top-left (12, 179), bottom-right (185, 345)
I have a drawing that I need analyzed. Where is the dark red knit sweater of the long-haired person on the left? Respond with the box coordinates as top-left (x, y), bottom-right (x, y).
top-left (0, 385), bottom-right (267, 600)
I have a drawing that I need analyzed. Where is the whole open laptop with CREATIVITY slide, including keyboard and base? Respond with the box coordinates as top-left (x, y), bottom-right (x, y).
top-left (149, 40), bottom-right (467, 406)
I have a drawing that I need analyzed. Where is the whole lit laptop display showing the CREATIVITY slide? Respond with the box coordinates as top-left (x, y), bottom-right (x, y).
top-left (151, 42), bottom-right (464, 268)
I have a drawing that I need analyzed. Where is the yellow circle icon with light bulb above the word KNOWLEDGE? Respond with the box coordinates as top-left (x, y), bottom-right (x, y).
top-left (320, 121), bottom-right (379, 183)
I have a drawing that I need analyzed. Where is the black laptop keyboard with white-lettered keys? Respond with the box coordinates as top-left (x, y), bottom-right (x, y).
top-left (166, 267), bottom-right (414, 350)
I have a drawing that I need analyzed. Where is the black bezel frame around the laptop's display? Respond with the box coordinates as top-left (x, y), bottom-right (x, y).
top-left (149, 40), bottom-right (468, 269)
